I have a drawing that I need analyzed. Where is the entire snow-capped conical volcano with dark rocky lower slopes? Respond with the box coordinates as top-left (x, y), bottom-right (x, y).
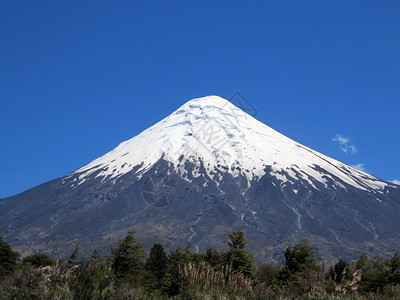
top-left (0, 96), bottom-right (400, 261)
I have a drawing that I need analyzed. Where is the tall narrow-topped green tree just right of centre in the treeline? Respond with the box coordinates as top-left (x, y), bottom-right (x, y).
top-left (225, 231), bottom-right (254, 276)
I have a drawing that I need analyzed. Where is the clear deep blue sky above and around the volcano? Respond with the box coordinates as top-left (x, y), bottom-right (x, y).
top-left (0, 0), bottom-right (400, 198)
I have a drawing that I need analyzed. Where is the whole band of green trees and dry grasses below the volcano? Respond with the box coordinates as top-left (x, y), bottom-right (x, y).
top-left (0, 231), bottom-right (400, 299)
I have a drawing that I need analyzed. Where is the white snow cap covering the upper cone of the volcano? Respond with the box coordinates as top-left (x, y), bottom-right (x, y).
top-left (74, 96), bottom-right (388, 190)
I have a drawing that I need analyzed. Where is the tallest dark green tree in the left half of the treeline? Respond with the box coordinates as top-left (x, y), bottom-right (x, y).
top-left (111, 231), bottom-right (144, 282)
